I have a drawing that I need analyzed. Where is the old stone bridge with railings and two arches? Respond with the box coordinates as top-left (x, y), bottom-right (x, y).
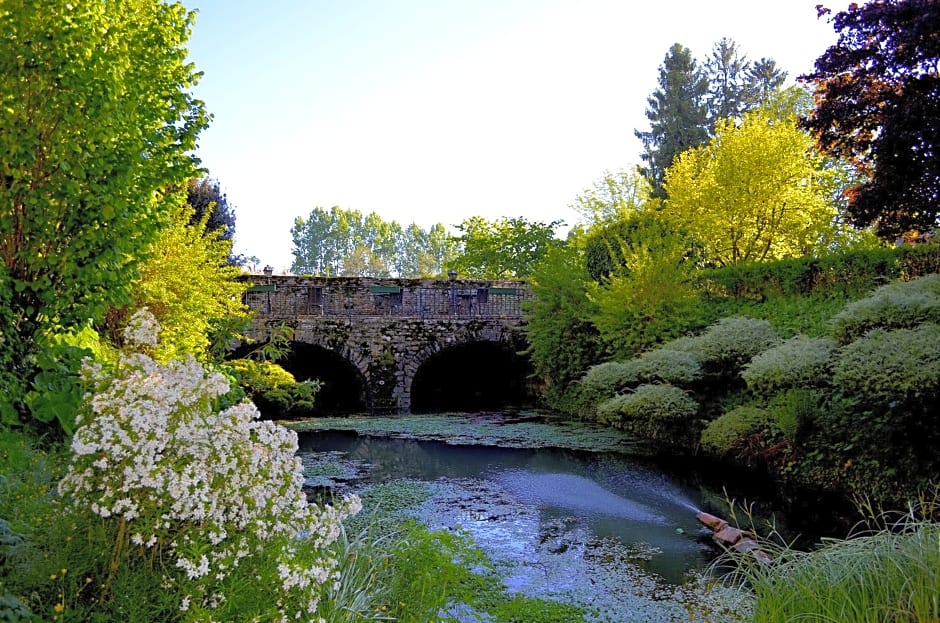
top-left (244, 275), bottom-right (532, 413)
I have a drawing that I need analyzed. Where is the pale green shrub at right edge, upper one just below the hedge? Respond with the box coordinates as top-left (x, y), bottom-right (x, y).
top-left (832, 275), bottom-right (940, 344)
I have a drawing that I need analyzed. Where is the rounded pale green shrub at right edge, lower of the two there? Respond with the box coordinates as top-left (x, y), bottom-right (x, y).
top-left (832, 323), bottom-right (940, 405)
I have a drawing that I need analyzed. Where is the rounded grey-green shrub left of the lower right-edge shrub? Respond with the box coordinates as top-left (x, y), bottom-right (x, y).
top-left (741, 335), bottom-right (836, 396)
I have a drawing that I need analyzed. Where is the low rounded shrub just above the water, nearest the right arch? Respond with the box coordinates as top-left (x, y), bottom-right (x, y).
top-left (597, 385), bottom-right (699, 443)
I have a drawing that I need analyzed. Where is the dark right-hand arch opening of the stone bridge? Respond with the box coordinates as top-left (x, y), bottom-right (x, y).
top-left (411, 342), bottom-right (535, 413)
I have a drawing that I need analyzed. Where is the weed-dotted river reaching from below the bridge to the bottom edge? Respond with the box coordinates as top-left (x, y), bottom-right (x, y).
top-left (300, 414), bottom-right (756, 622)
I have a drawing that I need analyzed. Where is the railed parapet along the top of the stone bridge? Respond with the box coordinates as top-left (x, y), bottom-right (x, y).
top-left (243, 275), bottom-right (532, 320)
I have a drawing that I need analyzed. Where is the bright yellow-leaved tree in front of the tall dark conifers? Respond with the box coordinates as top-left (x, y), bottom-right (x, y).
top-left (664, 110), bottom-right (836, 265)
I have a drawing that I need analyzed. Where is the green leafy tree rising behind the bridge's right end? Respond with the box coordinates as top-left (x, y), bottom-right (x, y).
top-left (453, 216), bottom-right (562, 279)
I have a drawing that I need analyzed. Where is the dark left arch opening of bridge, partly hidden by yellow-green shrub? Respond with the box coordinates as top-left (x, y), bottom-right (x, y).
top-left (279, 342), bottom-right (366, 415)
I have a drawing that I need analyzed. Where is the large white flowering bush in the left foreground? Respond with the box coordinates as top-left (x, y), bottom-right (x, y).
top-left (59, 311), bottom-right (360, 621)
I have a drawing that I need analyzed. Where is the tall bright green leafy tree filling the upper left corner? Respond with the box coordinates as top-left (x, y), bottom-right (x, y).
top-left (0, 0), bottom-right (207, 416)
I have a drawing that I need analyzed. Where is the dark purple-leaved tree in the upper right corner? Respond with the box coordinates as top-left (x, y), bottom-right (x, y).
top-left (800, 0), bottom-right (940, 239)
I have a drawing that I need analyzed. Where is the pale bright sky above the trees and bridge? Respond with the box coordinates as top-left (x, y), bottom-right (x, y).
top-left (184, 0), bottom-right (848, 273)
